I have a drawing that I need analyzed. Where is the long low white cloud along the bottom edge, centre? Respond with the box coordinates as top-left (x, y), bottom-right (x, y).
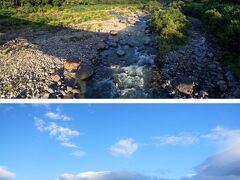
top-left (57, 171), bottom-right (163, 180)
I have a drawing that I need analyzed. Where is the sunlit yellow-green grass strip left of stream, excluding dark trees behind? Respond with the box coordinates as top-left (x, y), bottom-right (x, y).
top-left (0, 4), bottom-right (140, 33)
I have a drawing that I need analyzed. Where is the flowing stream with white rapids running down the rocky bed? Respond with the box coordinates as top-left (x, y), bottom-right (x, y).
top-left (86, 11), bottom-right (168, 98)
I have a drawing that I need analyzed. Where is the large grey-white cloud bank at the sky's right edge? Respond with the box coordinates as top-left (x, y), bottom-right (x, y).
top-left (183, 127), bottom-right (240, 180)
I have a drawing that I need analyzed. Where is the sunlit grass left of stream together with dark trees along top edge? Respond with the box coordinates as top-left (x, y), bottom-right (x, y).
top-left (0, 0), bottom-right (163, 33)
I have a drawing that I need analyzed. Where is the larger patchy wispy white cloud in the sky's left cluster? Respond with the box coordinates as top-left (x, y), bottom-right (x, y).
top-left (35, 117), bottom-right (80, 142)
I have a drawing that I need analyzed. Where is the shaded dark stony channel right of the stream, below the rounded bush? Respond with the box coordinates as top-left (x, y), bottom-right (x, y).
top-left (159, 18), bottom-right (240, 98)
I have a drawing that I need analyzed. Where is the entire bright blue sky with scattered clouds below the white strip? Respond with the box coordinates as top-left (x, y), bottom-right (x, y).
top-left (0, 104), bottom-right (240, 180)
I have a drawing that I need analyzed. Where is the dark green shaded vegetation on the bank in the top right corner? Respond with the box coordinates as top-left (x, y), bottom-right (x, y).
top-left (182, 0), bottom-right (240, 78)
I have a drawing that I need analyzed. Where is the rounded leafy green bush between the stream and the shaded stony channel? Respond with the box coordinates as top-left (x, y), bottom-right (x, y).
top-left (150, 7), bottom-right (188, 53)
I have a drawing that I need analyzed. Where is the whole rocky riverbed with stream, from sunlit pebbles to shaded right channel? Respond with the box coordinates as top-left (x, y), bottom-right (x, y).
top-left (0, 10), bottom-right (240, 98)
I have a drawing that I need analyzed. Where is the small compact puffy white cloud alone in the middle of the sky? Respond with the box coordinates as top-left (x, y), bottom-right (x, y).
top-left (109, 138), bottom-right (139, 157)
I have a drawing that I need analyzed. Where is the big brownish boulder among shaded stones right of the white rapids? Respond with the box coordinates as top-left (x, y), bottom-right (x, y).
top-left (176, 77), bottom-right (194, 95)
